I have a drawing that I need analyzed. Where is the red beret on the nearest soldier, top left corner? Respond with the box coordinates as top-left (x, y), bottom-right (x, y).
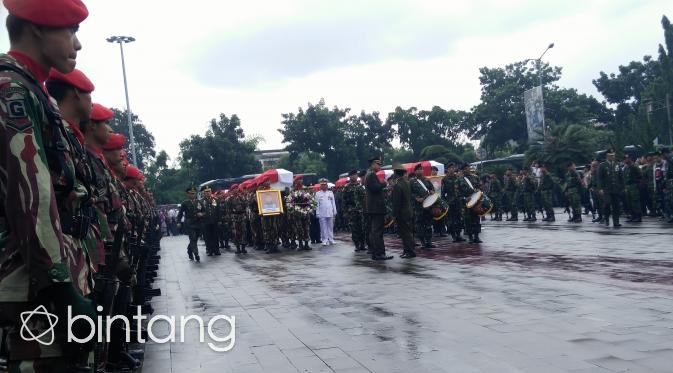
top-left (3, 0), bottom-right (89, 27)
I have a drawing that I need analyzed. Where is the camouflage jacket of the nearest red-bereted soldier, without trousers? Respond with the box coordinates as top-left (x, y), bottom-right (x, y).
top-left (0, 54), bottom-right (83, 302)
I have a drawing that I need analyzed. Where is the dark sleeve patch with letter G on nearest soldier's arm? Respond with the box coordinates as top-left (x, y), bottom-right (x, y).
top-left (0, 83), bottom-right (33, 132)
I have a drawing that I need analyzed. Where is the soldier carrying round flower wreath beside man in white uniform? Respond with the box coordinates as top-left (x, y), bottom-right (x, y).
top-left (285, 178), bottom-right (316, 251)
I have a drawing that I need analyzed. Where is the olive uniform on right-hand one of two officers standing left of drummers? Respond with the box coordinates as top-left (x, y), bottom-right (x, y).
top-left (391, 167), bottom-right (416, 258)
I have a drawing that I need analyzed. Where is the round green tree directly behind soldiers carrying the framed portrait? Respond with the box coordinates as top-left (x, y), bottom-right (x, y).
top-left (180, 114), bottom-right (261, 184)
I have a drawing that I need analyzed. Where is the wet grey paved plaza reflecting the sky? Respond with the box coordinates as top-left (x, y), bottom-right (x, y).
top-left (143, 213), bottom-right (673, 373)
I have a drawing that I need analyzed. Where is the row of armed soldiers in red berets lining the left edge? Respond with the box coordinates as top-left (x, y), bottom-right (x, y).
top-left (0, 0), bottom-right (160, 373)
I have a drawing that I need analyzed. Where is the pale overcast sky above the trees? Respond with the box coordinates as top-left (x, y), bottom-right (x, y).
top-left (0, 0), bottom-right (673, 159)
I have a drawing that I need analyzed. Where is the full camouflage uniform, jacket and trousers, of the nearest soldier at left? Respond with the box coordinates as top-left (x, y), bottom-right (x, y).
top-left (0, 49), bottom-right (96, 372)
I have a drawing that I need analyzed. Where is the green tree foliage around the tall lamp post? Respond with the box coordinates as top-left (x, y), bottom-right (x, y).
top-left (110, 108), bottom-right (156, 170)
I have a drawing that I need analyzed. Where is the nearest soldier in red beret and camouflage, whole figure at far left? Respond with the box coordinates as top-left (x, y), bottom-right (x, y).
top-left (0, 0), bottom-right (96, 373)
